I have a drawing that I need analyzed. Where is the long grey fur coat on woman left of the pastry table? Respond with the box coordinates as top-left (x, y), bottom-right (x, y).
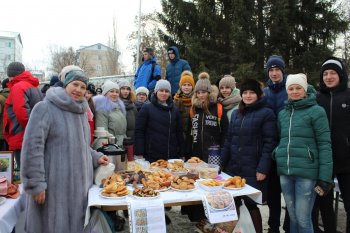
top-left (21, 87), bottom-right (102, 233)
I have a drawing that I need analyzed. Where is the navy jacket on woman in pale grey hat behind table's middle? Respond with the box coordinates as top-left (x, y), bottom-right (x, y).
top-left (135, 95), bottom-right (184, 163)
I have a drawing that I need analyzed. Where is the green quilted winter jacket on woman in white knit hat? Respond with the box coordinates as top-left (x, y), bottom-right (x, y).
top-left (273, 86), bottom-right (333, 182)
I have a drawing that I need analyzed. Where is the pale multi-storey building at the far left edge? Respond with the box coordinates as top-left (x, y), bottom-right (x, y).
top-left (0, 31), bottom-right (23, 79)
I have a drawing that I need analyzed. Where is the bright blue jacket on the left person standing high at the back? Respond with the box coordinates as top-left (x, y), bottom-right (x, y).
top-left (134, 56), bottom-right (161, 90)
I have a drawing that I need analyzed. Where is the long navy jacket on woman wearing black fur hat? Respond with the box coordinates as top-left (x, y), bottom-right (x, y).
top-left (221, 98), bottom-right (277, 198)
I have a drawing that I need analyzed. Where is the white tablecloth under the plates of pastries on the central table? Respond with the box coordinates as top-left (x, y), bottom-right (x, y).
top-left (85, 173), bottom-right (262, 224)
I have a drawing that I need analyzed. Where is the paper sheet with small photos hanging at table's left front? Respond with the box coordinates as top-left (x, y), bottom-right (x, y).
top-left (128, 199), bottom-right (166, 233)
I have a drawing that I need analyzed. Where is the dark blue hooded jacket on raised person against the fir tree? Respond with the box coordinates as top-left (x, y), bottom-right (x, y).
top-left (165, 46), bottom-right (191, 95)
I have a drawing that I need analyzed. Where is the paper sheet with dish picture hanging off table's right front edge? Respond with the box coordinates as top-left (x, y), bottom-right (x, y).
top-left (203, 191), bottom-right (238, 224)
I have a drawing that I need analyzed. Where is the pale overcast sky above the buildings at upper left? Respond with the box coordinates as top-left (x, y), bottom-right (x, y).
top-left (0, 0), bottom-right (161, 73)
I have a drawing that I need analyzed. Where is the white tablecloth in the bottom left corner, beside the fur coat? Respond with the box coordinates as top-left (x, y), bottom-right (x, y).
top-left (0, 185), bottom-right (25, 233)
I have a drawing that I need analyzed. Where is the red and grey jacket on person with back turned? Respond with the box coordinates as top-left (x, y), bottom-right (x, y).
top-left (3, 71), bottom-right (43, 150)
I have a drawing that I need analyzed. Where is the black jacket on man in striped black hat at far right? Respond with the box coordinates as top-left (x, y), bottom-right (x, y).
top-left (317, 61), bottom-right (350, 174)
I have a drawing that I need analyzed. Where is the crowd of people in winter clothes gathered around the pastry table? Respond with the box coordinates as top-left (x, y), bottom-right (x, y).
top-left (0, 50), bottom-right (350, 233)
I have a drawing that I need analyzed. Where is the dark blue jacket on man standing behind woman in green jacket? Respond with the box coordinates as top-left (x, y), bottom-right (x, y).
top-left (264, 75), bottom-right (288, 116)
